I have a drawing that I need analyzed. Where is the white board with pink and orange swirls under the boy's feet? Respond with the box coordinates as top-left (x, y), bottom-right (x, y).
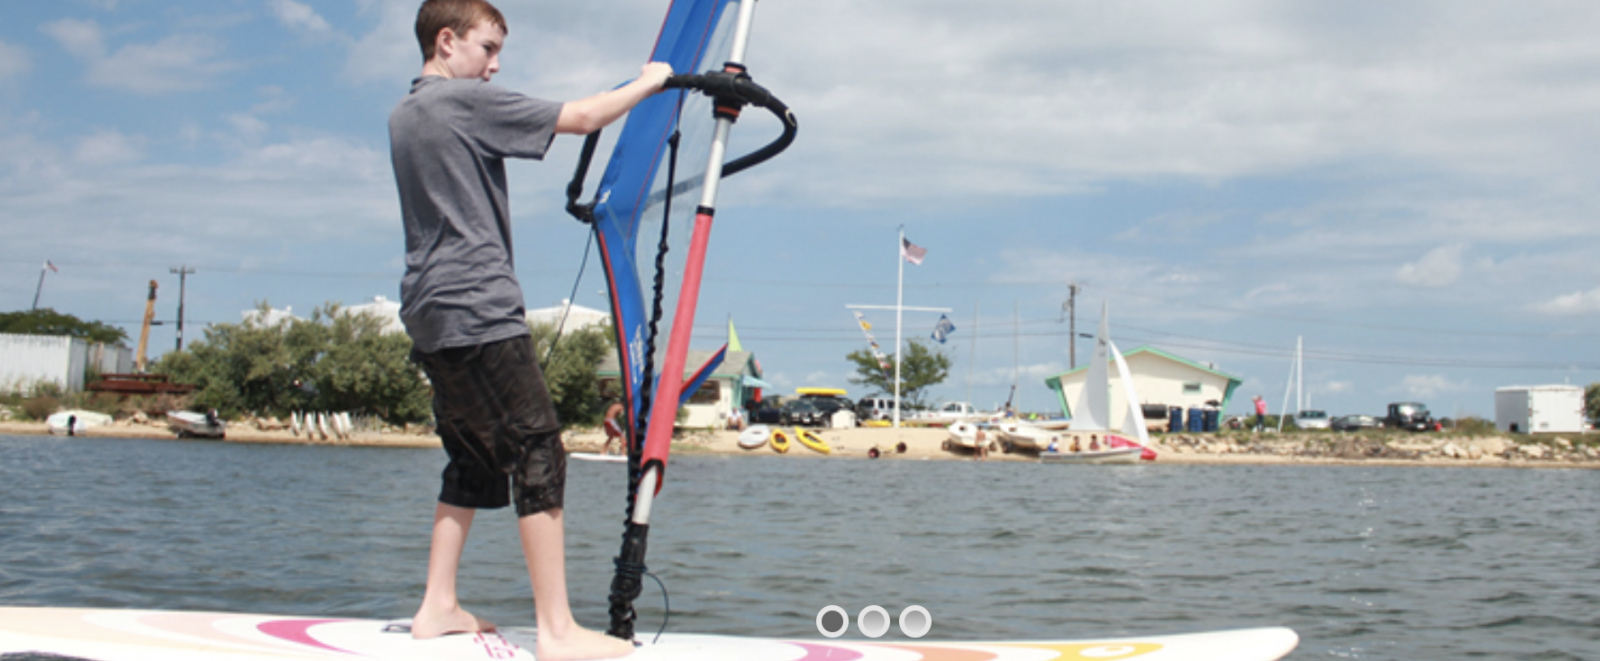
top-left (0, 608), bottom-right (1299, 661)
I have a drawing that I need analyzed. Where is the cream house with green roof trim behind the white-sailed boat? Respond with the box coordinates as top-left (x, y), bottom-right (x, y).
top-left (1045, 347), bottom-right (1245, 429)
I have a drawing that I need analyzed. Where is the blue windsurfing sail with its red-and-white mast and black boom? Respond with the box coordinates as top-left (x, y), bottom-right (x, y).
top-left (566, 0), bottom-right (797, 639)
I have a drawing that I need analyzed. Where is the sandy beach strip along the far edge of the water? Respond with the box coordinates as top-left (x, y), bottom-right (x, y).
top-left (0, 421), bottom-right (1600, 469)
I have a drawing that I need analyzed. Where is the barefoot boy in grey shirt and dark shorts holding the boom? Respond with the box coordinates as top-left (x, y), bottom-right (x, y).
top-left (389, 0), bottom-right (672, 652)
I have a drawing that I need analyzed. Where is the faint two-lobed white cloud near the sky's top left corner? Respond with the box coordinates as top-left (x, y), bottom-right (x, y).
top-left (43, 19), bottom-right (237, 94)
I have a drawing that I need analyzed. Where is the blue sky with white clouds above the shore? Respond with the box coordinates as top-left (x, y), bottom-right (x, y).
top-left (0, 0), bottom-right (1600, 418)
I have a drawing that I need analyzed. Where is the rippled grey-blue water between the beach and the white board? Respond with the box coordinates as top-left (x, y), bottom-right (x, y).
top-left (0, 437), bottom-right (1600, 661)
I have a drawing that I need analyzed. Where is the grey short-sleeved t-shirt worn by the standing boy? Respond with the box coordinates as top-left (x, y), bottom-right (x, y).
top-left (389, 75), bottom-right (562, 352)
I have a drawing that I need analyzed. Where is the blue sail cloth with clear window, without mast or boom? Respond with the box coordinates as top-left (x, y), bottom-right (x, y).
top-left (594, 0), bottom-right (739, 438)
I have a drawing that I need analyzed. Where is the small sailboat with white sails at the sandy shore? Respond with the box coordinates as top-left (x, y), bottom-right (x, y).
top-left (1038, 304), bottom-right (1155, 464)
